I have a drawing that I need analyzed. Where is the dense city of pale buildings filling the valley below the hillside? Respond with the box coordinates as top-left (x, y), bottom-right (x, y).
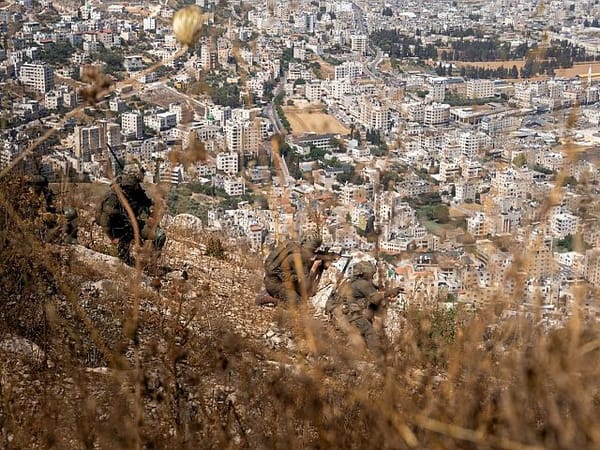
top-left (0, 0), bottom-right (600, 326)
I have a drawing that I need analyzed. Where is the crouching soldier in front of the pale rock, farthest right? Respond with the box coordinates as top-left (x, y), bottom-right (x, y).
top-left (325, 261), bottom-right (401, 351)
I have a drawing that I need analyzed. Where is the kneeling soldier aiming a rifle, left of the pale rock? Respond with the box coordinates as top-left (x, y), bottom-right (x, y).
top-left (257, 233), bottom-right (322, 304)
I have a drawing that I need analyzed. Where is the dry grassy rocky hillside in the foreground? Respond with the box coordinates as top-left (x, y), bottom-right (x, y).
top-left (0, 185), bottom-right (600, 449)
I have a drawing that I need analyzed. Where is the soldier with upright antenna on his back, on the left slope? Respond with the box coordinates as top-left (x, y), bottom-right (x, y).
top-left (96, 164), bottom-right (166, 266)
